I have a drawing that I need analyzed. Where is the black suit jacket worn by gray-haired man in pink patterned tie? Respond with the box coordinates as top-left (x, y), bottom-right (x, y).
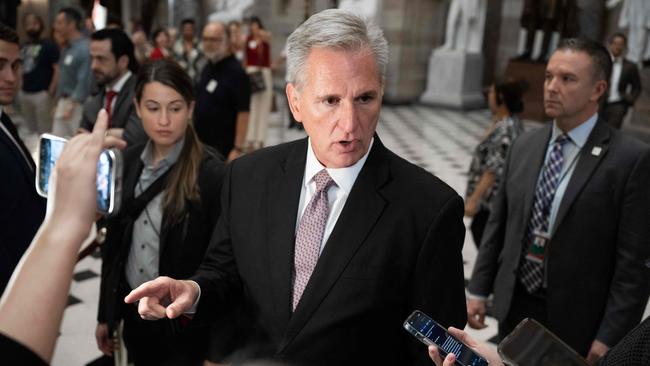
top-left (193, 137), bottom-right (466, 365)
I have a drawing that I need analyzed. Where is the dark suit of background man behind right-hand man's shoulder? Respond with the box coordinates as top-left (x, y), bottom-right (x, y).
top-left (602, 59), bottom-right (641, 129)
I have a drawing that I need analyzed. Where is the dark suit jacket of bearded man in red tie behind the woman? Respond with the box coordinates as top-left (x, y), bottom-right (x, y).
top-left (79, 75), bottom-right (148, 146)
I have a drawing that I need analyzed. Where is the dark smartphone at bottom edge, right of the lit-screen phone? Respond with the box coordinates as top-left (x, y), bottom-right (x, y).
top-left (497, 318), bottom-right (589, 366)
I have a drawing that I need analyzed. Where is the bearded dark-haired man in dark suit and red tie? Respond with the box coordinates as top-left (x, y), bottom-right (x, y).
top-left (79, 29), bottom-right (147, 145)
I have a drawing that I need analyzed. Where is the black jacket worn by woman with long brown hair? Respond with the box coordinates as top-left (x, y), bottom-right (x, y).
top-left (97, 144), bottom-right (225, 336)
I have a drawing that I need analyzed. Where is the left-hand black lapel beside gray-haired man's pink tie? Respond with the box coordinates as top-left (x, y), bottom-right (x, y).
top-left (266, 139), bottom-right (308, 329)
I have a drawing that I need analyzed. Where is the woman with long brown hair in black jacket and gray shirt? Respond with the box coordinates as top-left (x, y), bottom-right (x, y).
top-left (96, 60), bottom-right (224, 365)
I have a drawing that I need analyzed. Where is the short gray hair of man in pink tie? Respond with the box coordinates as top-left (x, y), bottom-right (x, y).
top-left (287, 9), bottom-right (388, 86)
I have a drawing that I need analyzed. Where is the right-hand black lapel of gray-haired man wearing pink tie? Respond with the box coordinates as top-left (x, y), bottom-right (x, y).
top-left (279, 136), bottom-right (389, 352)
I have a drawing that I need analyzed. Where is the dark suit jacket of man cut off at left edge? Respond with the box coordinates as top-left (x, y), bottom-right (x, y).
top-left (0, 112), bottom-right (45, 295)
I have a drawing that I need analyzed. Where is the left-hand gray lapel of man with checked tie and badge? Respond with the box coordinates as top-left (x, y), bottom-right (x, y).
top-left (517, 123), bottom-right (553, 231)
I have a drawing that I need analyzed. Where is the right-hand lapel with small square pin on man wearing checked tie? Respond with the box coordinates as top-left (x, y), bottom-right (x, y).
top-left (554, 120), bottom-right (609, 233)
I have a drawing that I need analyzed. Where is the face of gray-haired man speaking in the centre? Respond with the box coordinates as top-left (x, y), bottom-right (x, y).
top-left (288, 48), bottom-right (383, 168)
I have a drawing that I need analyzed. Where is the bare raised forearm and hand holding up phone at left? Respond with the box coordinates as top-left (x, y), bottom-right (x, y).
top-left (0, 111), bottom-right (124, 362)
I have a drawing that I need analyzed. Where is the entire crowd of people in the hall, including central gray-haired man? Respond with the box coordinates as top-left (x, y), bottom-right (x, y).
top-left (0, 8), bottom-right (650, 365)
